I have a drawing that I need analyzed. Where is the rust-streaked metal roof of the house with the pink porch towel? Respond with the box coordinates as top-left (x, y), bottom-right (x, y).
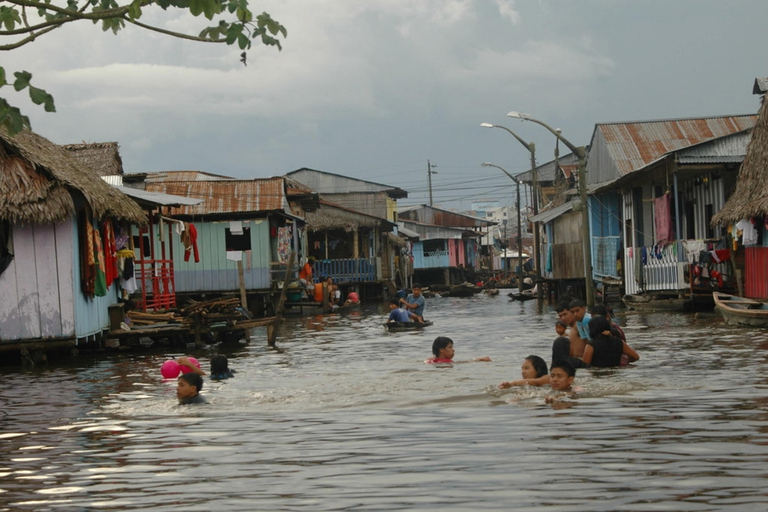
top-left (590, 114), bottom-right (757, 176)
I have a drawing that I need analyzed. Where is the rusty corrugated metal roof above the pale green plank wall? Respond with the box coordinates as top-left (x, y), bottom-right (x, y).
top-left (146, 178), bottom-right (288, 215)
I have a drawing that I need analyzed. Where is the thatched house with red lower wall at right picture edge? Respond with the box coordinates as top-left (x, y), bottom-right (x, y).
top-left (712, 78), bottom-right (768, 300)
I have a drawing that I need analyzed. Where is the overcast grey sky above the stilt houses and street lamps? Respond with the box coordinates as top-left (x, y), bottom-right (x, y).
top-left (0, 0), bottom-right (768, 210)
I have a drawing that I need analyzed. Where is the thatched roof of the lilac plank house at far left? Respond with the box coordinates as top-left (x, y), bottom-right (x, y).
top-left (0, 129), bottom-right (146, 224)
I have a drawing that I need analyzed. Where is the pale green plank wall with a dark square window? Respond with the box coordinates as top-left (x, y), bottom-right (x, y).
top-left (173, 219), bottom-right (271, 292)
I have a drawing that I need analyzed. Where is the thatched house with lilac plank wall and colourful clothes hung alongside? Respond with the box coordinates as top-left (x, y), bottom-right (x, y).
top-left (0, 131), bottom-right (146, 356)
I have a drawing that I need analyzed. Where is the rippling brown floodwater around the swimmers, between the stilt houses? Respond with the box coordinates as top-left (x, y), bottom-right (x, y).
top-left (0, 295), bottom-right (768, 511)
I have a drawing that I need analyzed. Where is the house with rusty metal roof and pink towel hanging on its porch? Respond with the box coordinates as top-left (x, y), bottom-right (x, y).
top-left (587, 115), bottom-right (756, 306)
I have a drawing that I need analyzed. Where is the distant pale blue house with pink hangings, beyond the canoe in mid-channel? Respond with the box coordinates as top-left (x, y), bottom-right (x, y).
top-left (398, 205), bottom-right (495, 284)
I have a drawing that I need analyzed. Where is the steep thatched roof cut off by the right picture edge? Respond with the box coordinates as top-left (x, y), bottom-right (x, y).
top-left (712, 96), bottom-right (768, 225)
